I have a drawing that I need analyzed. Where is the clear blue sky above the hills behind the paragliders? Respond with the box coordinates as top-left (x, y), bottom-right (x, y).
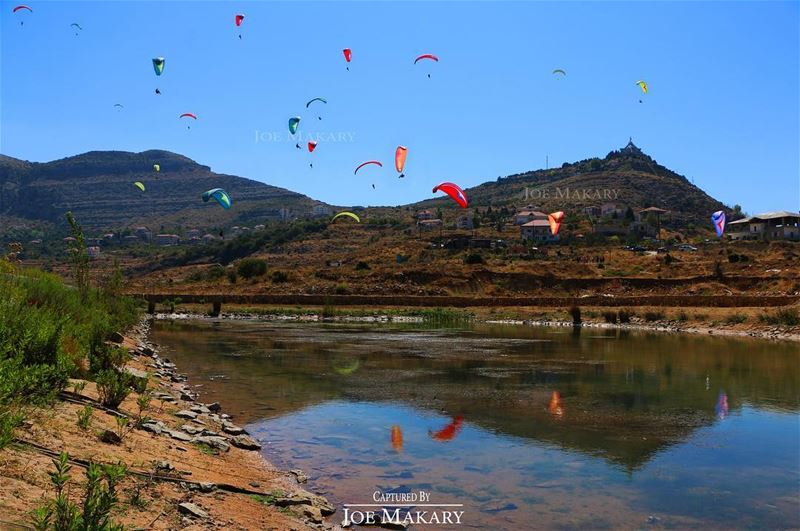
top-left (0, 0), bottom-right (800, 213)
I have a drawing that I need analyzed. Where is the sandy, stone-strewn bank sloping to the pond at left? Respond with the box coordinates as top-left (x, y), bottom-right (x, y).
top-left (0, 321), bottom-right (338, 530)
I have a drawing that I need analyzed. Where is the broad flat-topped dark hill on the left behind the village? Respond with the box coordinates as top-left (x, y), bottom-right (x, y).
top-left (0, 150), bottom-right (318, 229)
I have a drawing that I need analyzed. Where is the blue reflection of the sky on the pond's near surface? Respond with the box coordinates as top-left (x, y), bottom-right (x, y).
top-left (255, 401), bottom-right (800, 527)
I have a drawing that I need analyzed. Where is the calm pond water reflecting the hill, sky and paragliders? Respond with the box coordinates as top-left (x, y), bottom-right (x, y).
top-left (154, 321), bottom-right (800, 529)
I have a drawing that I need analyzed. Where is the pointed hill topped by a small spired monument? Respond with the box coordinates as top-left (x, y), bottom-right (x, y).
top-left (409, 141), bottom-right (725, 224)
